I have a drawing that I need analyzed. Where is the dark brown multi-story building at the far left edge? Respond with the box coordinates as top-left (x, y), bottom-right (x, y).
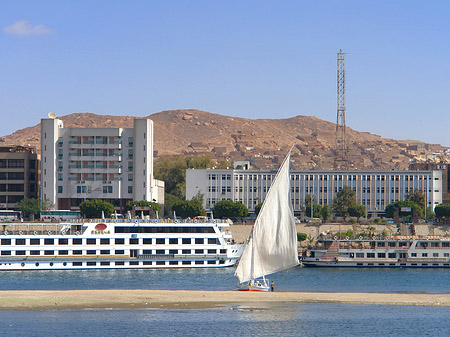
top-left (0, 146), bottom-right (39, 210)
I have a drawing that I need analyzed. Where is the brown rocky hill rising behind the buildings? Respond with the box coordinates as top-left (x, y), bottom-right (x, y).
top-left (2, 110), bottom-right (443, 169)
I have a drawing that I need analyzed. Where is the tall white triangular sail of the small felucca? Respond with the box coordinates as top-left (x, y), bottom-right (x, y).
top-left (235, 148), bottom-right (299, 283)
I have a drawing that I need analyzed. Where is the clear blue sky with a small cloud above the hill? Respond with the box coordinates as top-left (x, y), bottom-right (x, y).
top-left (0, 0), bottom-right (450, 146)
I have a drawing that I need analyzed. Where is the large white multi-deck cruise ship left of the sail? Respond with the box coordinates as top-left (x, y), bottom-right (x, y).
top-left (0, 219), bottom-right (243, 270)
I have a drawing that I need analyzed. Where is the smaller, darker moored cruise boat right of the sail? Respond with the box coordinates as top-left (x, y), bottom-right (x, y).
top-left (302, 235), bottom-right (450, 268)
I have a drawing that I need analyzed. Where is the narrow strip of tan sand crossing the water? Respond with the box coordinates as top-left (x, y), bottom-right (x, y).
top-left (0, 289), bottom-right (450, 310)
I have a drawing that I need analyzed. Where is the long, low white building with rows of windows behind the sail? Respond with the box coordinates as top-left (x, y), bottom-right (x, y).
top-left (186, 169), bottom-right (443, 215)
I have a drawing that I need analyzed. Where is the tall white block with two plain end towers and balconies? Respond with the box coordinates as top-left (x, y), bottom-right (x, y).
top-left (41, 118), bottom-right (164, 210)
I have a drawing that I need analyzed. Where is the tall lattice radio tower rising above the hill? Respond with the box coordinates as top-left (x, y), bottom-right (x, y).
top-left (334, 49), bottom-right (349, 170)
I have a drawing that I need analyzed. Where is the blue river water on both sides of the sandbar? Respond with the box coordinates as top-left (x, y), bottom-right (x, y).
top-left (0, 268), bottom-right (450, 336)
